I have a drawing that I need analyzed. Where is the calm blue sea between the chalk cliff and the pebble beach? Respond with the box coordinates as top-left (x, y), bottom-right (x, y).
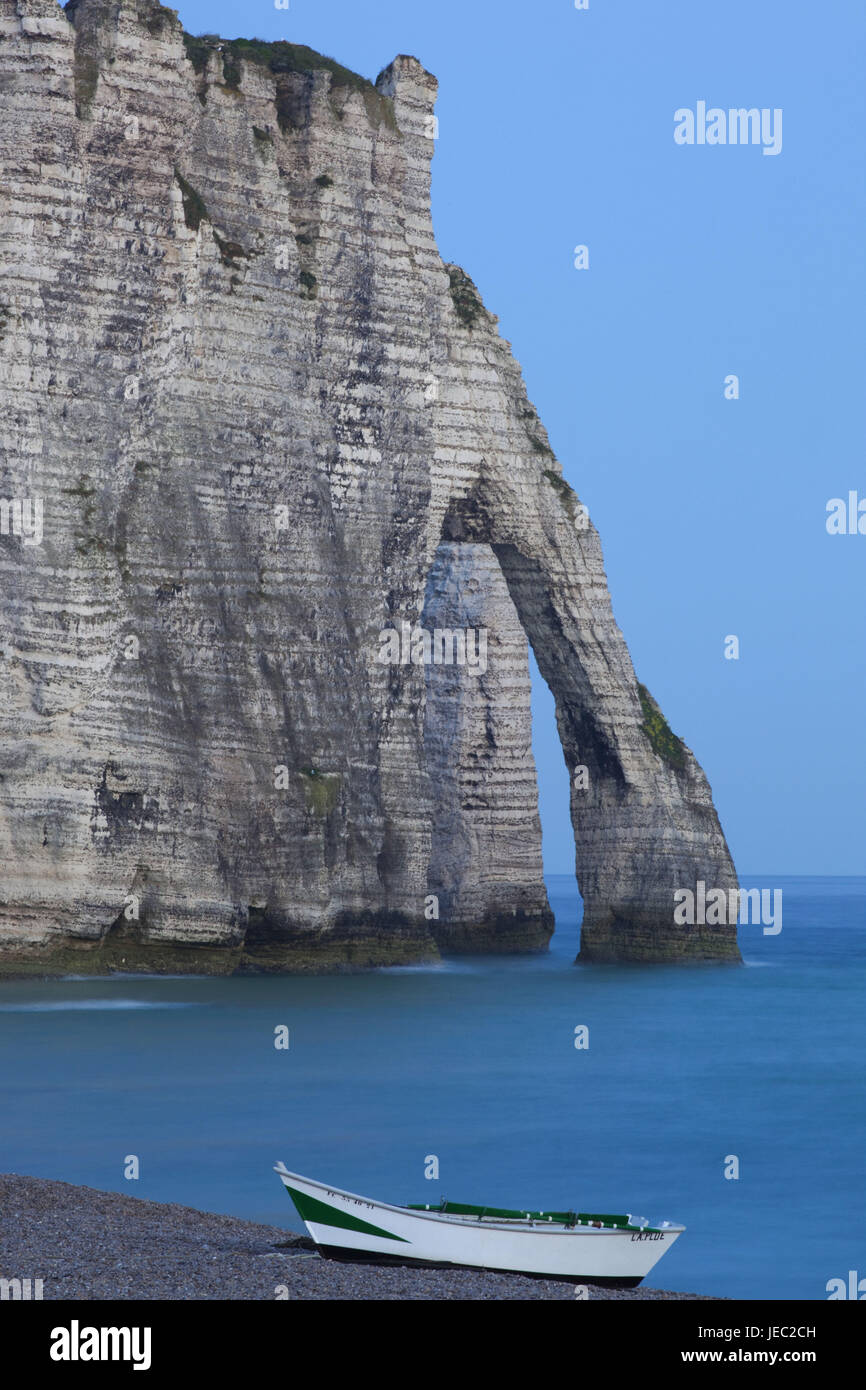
top-left (0, 876), bottom-right (866, 1298)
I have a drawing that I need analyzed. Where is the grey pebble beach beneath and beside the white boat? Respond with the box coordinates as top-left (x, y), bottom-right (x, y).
top-left (0, 1173), bottom-right (717, 1301)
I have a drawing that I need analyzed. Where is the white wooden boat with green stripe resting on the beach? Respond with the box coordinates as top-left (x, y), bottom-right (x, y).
top-left (275, 1163), bottom-right (685, 1289)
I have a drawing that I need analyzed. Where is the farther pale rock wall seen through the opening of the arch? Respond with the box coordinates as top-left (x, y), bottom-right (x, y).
top-left (423, 541), bottom-right (553, 952)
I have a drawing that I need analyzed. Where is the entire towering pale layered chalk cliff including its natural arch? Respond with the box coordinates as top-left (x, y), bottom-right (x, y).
top-left (0, 0), bottom-right (737, 972)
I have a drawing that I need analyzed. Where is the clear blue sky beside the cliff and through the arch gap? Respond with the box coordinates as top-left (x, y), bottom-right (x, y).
top-left (173, 0), bottom-right (866, 874)
